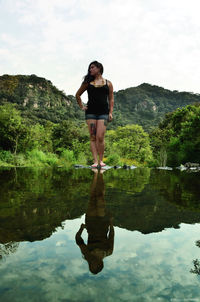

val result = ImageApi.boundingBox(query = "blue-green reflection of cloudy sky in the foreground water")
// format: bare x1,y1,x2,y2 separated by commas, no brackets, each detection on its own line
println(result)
0,216,200,302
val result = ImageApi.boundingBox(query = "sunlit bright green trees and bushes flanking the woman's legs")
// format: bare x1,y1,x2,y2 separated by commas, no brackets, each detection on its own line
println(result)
0,103,152,167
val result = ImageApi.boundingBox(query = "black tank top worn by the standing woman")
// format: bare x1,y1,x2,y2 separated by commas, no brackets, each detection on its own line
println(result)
86,80,109,115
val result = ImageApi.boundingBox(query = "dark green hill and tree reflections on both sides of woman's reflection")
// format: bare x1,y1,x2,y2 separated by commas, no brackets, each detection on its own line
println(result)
0,169,200,243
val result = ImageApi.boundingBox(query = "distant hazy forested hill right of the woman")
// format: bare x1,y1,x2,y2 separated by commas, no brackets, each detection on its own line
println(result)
115,83,200,130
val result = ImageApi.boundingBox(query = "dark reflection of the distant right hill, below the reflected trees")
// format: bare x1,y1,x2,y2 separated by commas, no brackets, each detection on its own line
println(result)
111,186,200,234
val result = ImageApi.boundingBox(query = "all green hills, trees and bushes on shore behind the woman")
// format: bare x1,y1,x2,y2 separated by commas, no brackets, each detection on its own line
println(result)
0,75,200,167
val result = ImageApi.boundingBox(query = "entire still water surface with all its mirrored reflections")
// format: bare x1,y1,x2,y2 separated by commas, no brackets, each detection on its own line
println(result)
0,168,200,302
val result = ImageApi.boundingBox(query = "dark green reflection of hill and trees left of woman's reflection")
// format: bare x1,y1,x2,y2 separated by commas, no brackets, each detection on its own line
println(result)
0,169,92,243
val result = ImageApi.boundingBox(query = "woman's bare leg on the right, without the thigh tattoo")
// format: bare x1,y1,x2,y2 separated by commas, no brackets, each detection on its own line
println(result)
96,120,106,165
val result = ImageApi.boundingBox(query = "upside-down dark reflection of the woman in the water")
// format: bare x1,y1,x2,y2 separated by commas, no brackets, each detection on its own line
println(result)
76,169,114,274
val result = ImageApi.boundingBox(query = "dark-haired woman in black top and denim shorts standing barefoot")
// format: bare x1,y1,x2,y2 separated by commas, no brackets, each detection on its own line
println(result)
76,61,114,168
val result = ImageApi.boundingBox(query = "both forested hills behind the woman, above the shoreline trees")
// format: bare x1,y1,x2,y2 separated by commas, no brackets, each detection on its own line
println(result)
0,75,200,130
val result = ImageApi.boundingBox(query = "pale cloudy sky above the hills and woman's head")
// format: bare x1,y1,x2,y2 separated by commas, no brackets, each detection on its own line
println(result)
0,0,200,99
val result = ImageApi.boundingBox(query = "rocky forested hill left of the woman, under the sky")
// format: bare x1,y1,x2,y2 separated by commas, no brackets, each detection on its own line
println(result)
0,75,84,124
